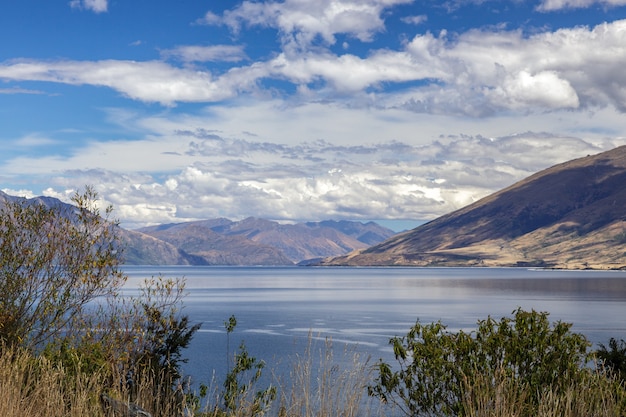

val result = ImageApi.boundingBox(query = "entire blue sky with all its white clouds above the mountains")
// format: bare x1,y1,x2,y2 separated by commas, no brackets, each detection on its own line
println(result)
0,0,626,228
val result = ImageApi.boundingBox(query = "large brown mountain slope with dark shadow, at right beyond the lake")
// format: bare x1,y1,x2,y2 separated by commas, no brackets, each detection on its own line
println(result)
323,146,626,269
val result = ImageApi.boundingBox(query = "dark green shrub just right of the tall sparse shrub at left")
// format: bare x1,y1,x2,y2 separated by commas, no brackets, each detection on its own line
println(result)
113,276,201,415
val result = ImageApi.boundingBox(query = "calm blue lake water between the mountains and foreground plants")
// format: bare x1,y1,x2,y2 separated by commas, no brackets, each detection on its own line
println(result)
124,266,626,382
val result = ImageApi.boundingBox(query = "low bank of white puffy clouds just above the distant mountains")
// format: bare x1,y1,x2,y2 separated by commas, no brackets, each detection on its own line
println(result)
94,133,600,228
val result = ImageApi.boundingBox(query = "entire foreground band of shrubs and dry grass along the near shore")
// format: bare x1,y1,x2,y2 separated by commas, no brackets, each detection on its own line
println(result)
0,188,626,417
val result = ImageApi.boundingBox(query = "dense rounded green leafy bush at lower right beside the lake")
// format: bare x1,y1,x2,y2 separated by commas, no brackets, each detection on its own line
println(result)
368,309,590,416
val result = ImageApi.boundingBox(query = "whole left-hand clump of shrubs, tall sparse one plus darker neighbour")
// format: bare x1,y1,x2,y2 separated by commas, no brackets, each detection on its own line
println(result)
0,187,199,415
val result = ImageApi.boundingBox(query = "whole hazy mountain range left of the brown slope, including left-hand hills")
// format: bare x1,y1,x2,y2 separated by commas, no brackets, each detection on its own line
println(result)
0,191,395,265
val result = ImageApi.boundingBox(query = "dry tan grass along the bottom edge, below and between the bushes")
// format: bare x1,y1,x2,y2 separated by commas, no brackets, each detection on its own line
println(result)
0,337,626,417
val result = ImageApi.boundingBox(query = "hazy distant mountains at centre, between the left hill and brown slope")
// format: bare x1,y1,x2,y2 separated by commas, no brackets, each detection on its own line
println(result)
137,217,394,265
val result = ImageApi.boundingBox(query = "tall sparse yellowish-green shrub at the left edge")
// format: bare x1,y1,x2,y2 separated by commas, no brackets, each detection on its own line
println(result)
0,187,125,348
